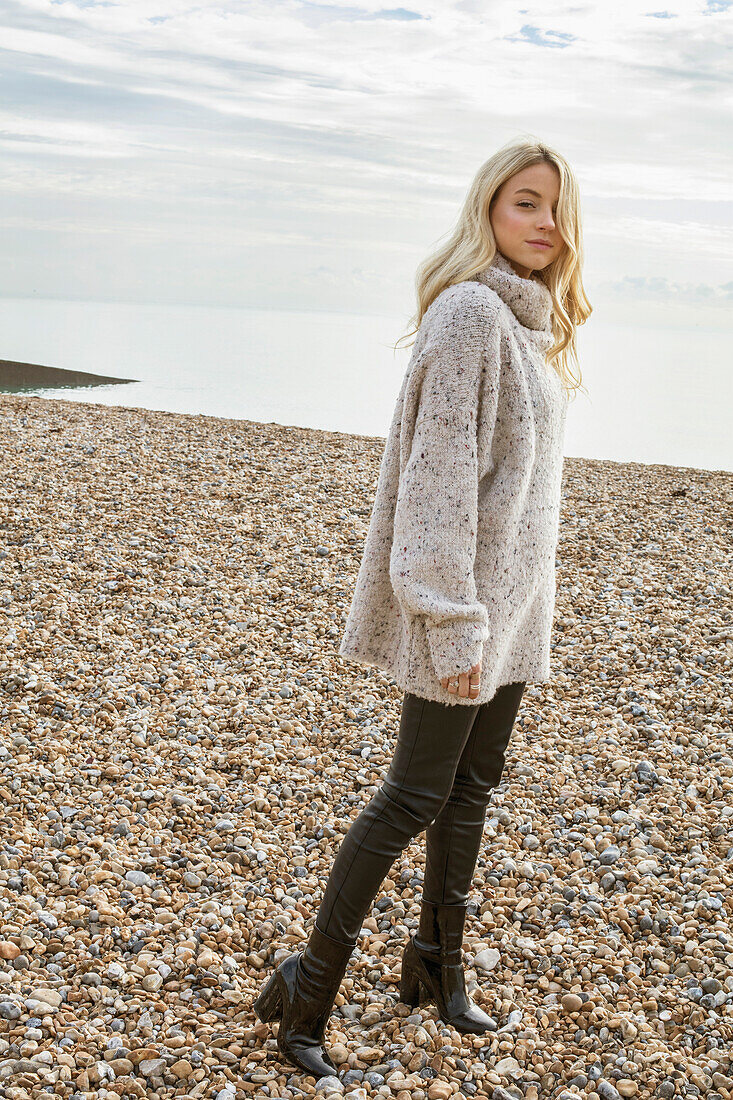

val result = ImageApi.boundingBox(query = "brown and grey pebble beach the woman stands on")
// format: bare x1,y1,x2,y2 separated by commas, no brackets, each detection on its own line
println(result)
0,394,733,1100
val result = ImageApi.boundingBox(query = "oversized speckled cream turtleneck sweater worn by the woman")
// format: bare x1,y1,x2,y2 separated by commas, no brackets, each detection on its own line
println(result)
339,252,568,706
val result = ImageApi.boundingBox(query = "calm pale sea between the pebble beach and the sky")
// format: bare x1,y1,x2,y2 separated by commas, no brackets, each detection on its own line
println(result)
0,298,733,470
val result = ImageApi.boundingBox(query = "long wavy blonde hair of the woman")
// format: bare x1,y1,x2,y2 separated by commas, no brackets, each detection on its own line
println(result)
393,139,593,396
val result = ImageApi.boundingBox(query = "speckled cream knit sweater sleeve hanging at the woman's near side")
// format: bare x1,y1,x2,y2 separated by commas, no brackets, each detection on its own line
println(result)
390,287,499,679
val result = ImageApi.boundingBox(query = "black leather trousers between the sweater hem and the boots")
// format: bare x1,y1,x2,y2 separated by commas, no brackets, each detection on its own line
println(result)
316,682,525,941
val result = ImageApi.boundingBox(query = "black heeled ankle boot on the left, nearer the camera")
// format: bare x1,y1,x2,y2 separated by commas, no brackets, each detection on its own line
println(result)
254,925,357,1078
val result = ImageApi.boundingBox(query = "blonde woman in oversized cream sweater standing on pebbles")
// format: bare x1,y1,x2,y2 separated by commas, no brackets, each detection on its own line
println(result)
254,135,591,1078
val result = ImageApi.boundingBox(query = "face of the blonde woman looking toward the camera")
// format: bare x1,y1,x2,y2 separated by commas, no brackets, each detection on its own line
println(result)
489,162,565,278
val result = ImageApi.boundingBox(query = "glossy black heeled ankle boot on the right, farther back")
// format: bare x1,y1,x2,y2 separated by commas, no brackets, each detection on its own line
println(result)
400,902,497,1035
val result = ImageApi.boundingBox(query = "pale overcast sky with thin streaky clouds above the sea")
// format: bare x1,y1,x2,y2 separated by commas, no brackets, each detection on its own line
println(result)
0,0,733,325
